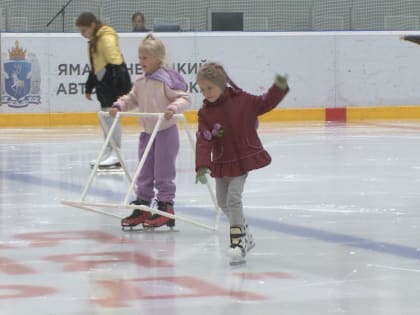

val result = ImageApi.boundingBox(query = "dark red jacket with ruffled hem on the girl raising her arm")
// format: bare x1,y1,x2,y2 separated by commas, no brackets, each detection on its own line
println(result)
195,85,289,177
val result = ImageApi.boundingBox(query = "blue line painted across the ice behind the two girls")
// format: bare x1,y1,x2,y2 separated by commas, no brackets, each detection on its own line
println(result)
0,170,420,260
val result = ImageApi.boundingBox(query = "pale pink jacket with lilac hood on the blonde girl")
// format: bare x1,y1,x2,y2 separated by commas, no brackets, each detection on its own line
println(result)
113,68,191,133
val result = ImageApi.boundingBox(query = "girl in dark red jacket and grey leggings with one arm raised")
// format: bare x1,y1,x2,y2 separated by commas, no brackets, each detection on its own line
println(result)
196,63,289,264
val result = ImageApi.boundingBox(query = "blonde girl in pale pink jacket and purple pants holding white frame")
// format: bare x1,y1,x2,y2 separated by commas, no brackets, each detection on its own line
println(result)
110,34,190,229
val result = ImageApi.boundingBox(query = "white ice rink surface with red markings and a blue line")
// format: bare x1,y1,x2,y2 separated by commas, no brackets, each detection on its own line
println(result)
0,122,420,315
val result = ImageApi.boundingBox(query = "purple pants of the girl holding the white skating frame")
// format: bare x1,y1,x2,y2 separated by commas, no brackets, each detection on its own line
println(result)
137,125,179,202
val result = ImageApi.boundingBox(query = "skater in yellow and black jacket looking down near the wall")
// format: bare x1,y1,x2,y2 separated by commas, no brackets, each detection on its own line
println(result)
76,12,131,168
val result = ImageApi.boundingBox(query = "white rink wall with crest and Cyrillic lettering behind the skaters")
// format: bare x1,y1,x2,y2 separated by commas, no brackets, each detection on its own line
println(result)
0,32,420,113
